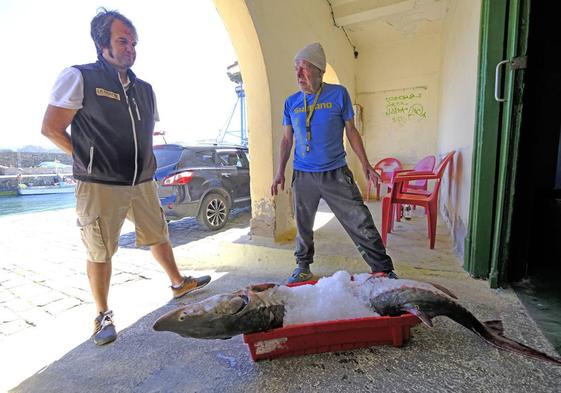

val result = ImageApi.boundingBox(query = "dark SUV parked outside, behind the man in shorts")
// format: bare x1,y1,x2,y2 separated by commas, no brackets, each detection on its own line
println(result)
154,144,251,230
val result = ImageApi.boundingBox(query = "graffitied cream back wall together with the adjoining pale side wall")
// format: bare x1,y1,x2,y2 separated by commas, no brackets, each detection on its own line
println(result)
355,0,481,255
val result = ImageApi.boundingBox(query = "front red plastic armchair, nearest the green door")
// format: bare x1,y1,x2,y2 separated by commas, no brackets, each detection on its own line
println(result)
382,151,455,249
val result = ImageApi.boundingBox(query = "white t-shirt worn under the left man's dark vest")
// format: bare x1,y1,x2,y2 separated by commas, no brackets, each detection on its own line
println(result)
49,67,160,121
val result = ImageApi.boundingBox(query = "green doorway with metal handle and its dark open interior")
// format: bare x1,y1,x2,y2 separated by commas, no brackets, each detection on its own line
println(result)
465,0,561,351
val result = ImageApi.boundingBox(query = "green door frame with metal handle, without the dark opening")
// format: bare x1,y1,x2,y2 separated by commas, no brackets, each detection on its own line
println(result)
464,0,531,288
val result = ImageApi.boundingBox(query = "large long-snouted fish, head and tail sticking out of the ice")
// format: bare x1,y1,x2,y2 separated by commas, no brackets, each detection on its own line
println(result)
154,274,561,365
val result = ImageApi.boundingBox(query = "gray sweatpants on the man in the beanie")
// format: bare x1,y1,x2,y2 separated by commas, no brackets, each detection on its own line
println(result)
292,166,393,272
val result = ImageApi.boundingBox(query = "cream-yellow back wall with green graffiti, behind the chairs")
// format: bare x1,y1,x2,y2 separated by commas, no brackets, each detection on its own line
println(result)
356,21,441,167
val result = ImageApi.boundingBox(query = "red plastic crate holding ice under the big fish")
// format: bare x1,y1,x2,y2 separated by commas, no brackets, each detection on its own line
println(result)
244,280,420,361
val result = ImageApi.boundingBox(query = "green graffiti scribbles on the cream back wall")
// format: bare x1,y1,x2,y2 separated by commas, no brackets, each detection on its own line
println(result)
384,88,427,125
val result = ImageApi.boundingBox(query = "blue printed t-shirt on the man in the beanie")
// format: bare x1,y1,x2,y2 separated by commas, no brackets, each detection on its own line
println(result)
282,83,354,172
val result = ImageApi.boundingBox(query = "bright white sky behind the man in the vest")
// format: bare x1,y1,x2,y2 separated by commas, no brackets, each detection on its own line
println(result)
0,0,239,149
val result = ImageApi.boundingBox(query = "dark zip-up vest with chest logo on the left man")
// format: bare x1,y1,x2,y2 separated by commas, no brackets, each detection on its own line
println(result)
71,56,156,185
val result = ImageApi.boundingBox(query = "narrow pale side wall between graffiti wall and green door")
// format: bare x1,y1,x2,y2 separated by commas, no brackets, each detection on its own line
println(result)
437,0,481,255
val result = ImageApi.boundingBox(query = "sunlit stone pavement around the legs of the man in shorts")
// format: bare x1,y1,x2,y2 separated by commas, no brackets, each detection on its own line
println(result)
0,209,250,392
